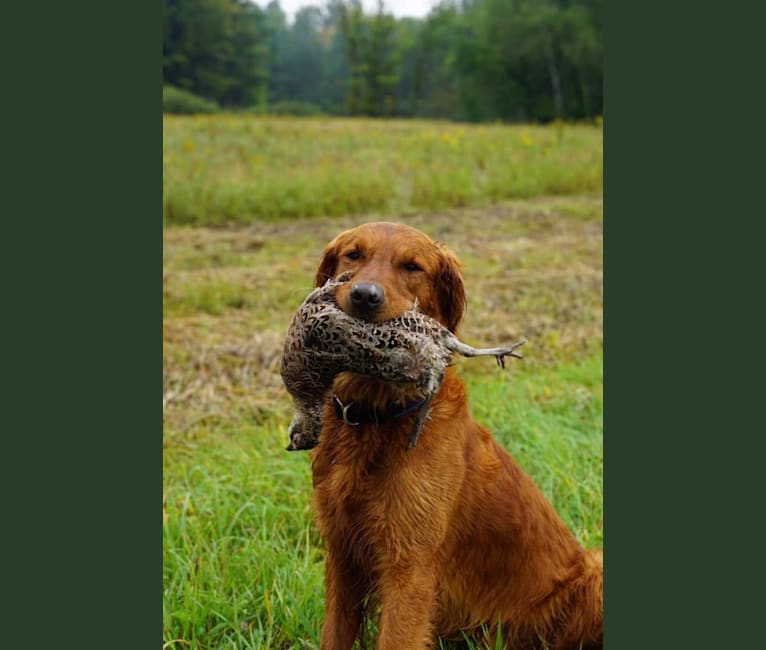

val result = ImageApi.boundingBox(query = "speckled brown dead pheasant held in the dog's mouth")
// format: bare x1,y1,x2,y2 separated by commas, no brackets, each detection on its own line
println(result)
280,273,526,451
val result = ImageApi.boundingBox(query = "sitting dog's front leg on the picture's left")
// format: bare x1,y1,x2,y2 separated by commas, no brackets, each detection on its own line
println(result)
320,550,365,650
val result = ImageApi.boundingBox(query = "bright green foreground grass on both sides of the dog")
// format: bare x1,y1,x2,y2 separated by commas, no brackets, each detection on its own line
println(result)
164,355,603,648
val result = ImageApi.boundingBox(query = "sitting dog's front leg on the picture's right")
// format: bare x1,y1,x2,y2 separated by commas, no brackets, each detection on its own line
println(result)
378,567,435,650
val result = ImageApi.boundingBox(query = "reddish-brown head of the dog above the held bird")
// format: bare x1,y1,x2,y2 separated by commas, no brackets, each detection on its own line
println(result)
316,222,466,332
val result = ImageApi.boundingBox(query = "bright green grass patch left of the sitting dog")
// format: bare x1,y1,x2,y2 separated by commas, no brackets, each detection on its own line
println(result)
163,422,322,648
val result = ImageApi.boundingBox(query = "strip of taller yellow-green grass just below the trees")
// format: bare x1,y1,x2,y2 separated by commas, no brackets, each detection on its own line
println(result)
163,115,603,225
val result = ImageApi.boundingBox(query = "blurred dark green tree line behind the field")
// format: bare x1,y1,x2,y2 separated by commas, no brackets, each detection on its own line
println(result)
163,0,603,121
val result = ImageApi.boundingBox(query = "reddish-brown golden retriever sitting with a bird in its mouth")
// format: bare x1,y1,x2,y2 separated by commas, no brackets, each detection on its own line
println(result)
311,222,603,650
